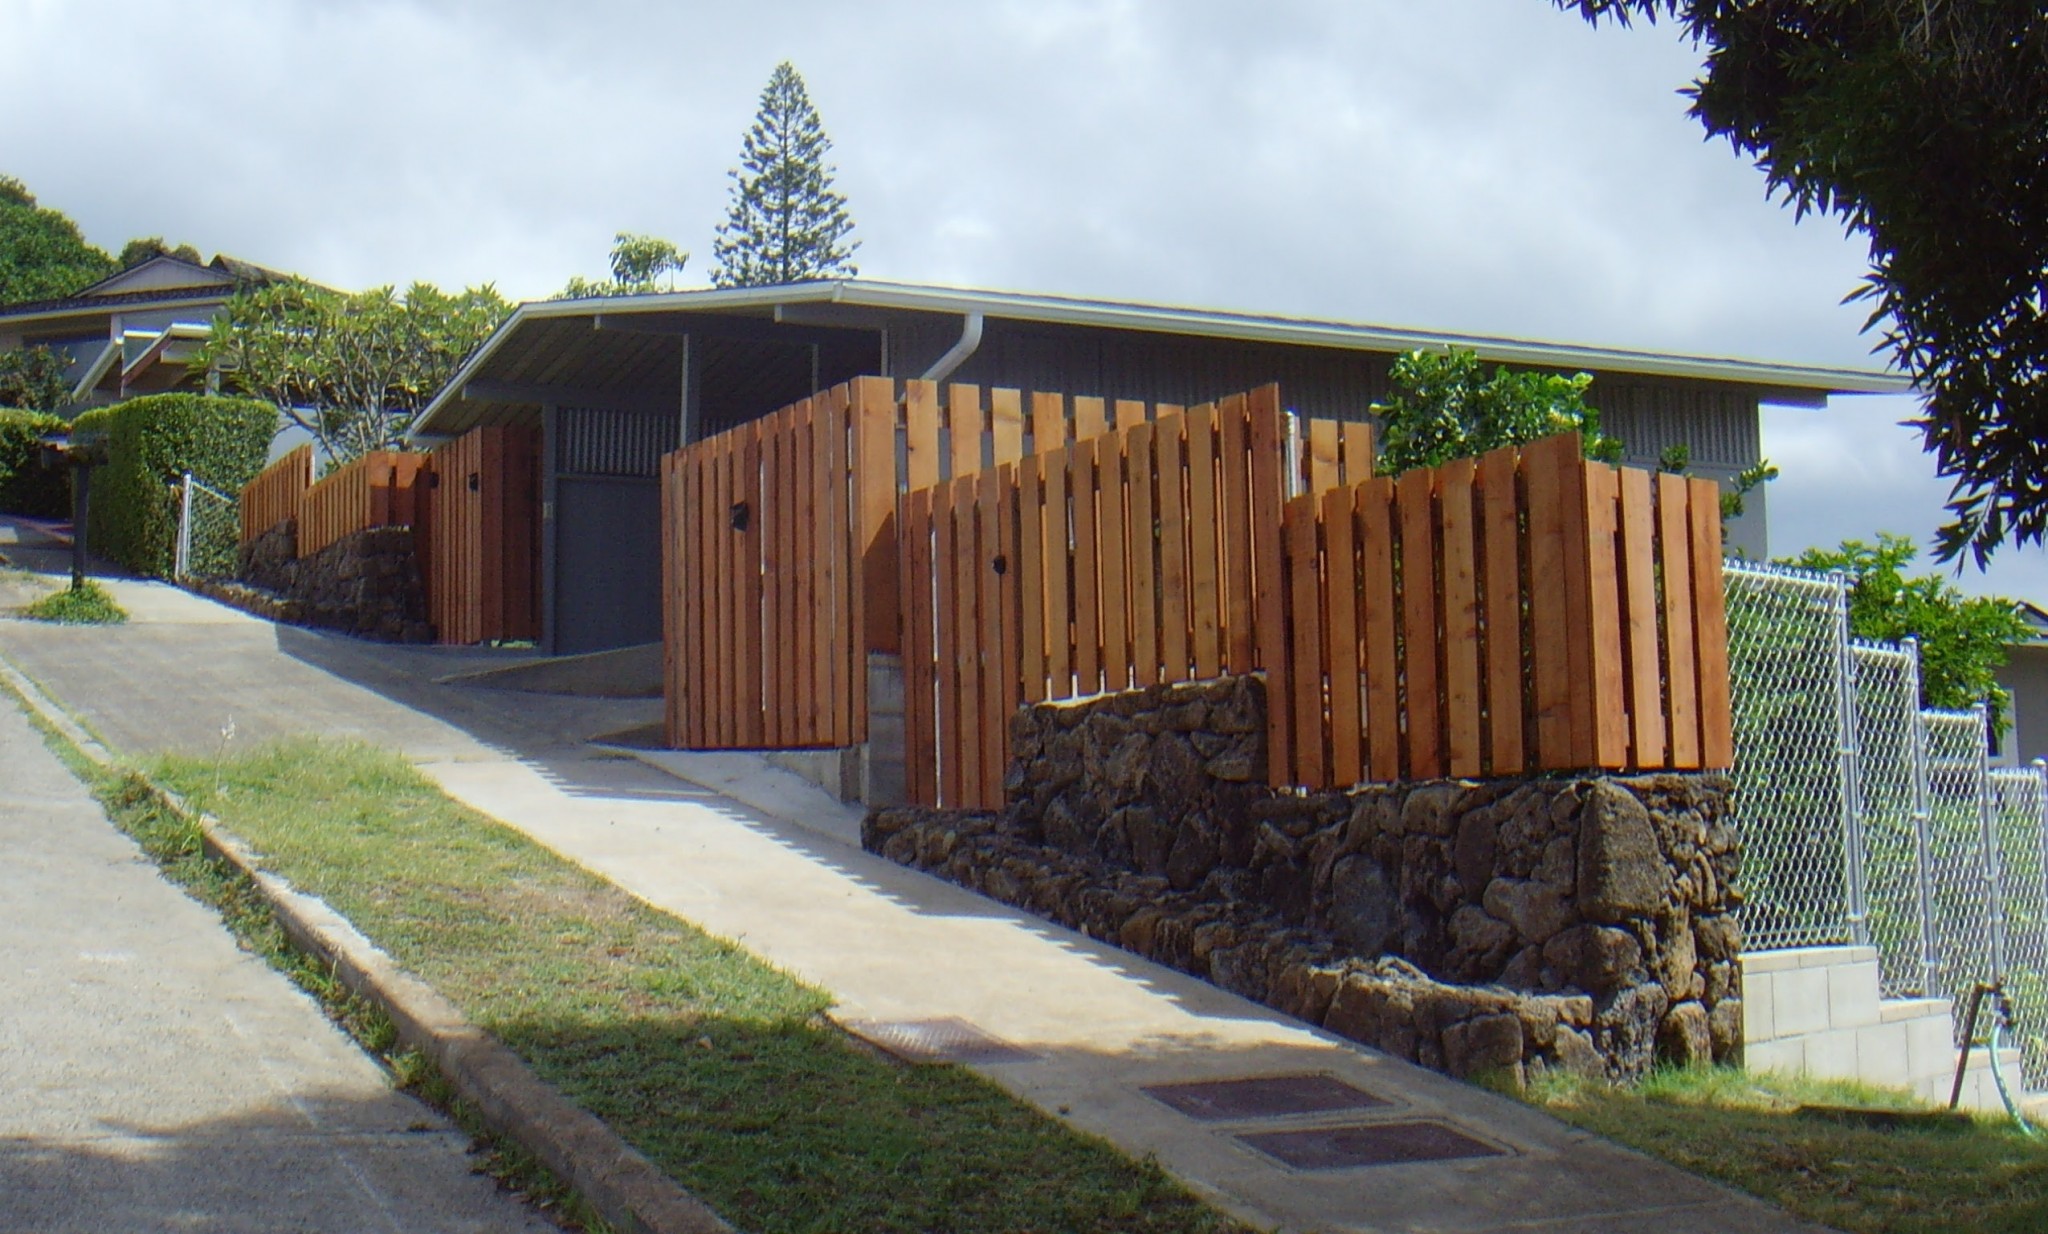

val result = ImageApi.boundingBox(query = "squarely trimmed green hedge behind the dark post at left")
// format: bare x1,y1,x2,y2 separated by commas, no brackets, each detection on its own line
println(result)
72,395,276,577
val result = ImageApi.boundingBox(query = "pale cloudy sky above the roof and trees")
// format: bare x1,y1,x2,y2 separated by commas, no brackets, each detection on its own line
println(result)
0,0,2048,600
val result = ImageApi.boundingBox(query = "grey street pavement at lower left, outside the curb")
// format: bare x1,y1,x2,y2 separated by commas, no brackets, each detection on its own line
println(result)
0,687,555,1234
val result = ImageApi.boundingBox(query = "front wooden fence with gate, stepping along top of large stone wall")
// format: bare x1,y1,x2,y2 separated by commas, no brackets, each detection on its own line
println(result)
899,387,1731,808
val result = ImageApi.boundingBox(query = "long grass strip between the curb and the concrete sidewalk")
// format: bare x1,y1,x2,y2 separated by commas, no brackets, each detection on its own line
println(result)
150,741,1239,1234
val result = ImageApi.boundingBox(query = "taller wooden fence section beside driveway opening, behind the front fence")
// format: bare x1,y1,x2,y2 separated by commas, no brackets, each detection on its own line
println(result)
662,377,1360,749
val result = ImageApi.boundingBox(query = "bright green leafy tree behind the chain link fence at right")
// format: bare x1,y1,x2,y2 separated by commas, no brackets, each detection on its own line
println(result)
1792,532,2030,731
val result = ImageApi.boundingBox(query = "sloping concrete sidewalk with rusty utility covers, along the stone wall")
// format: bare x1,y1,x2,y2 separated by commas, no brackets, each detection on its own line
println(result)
0,540,1810,1234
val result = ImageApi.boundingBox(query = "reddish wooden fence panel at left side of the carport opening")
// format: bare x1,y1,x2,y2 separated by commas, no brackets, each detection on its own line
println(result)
414,426,541,645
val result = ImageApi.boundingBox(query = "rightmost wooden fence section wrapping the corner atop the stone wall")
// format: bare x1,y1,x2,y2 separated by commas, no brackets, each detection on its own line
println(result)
1268,434,1733,788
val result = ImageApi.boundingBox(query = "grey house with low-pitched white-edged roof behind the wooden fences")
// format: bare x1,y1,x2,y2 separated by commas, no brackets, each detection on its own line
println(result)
412,280,1905,653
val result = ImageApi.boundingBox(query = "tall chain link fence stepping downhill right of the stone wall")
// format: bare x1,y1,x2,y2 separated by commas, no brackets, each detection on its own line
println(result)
1726,561,2048,1089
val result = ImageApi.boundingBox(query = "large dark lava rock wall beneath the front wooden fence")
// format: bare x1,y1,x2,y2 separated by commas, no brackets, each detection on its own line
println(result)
864,677,1741,1078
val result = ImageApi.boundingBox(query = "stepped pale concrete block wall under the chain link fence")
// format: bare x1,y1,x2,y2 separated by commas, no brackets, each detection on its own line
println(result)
1743,947,2019,1109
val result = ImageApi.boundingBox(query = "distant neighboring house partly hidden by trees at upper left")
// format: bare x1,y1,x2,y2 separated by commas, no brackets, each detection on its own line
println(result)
0,254,289,413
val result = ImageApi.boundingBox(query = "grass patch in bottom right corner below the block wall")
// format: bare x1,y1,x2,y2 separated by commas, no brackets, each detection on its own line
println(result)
1522,1066,2048,1234
